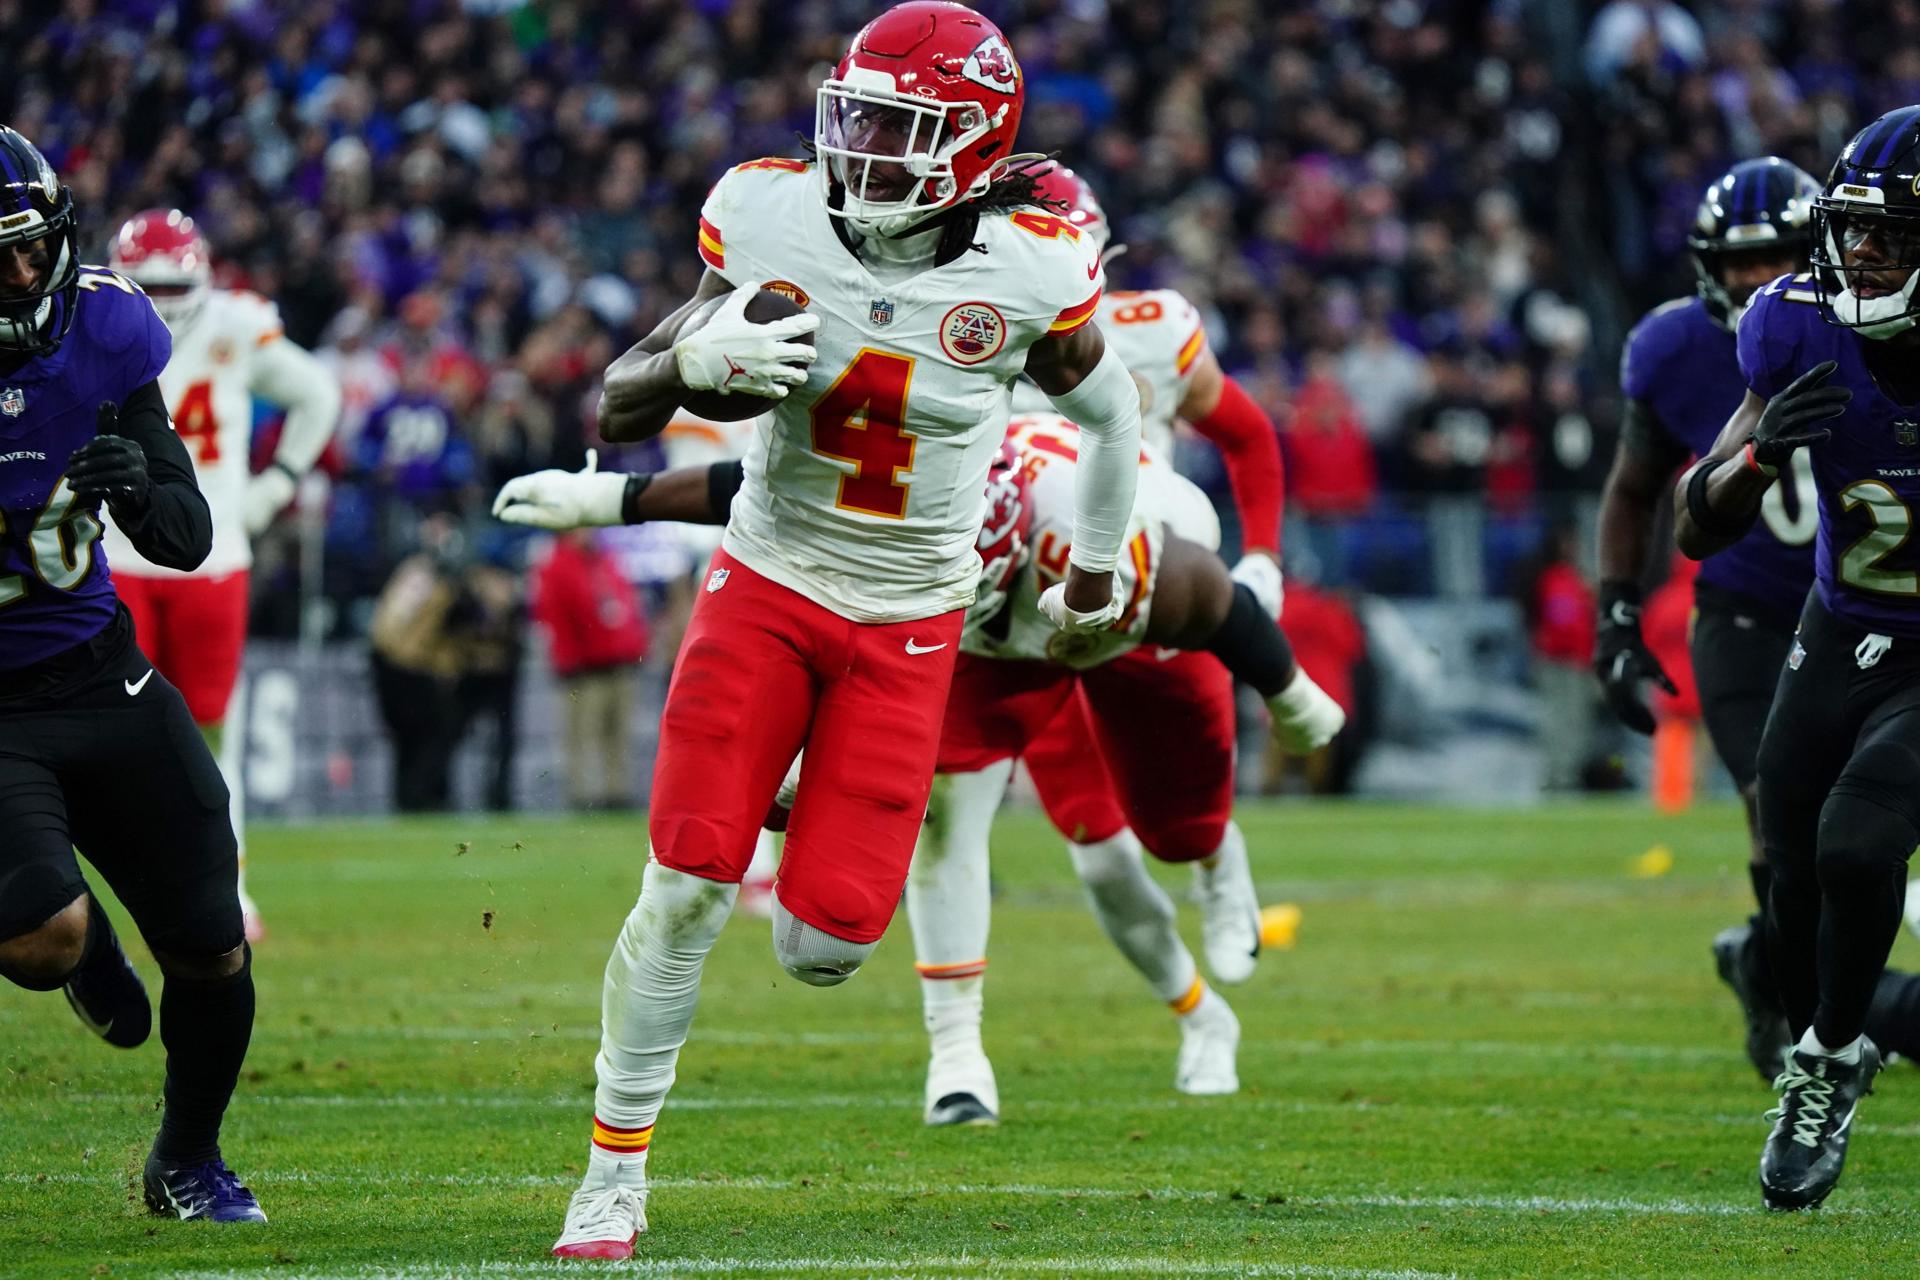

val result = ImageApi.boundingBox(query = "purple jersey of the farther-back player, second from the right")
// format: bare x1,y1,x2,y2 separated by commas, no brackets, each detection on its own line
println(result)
1620,297,1818,620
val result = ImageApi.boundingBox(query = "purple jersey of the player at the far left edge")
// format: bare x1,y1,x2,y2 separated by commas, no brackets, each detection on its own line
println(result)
0,267,173,670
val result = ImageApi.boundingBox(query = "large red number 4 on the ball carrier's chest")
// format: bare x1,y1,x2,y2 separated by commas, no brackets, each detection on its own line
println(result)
812,347,920,520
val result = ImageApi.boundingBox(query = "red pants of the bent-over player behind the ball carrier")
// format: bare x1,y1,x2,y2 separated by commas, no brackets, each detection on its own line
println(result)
939,649,1235,862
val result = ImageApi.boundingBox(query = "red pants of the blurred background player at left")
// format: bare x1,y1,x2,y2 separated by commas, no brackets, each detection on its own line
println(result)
113,568,248,725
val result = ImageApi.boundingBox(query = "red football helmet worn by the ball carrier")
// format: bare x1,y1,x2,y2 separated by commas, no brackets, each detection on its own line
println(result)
814,0,1027,236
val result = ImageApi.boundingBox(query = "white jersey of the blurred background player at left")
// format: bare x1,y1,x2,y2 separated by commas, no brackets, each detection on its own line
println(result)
106,290,282,578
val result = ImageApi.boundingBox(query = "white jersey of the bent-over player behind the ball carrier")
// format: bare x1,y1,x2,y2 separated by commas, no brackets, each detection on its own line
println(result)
960,415,1219,672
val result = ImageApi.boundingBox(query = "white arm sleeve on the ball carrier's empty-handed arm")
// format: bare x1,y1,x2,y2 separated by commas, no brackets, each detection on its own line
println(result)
1052,347,1140,574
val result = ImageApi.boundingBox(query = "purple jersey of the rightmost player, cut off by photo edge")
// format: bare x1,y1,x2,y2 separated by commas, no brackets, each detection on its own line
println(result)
1740,274,1920,639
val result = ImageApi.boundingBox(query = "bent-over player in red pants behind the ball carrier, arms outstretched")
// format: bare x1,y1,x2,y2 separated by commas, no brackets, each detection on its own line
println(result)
493,415,1344,1125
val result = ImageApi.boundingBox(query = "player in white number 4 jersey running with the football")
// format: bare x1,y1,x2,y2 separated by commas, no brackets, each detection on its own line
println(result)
533,0,1140,1257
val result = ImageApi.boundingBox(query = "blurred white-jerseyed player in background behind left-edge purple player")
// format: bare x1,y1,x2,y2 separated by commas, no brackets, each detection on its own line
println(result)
106,209,340,942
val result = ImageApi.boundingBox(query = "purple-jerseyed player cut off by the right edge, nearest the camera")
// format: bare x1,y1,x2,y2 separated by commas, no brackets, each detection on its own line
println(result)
1674,106,1920,1209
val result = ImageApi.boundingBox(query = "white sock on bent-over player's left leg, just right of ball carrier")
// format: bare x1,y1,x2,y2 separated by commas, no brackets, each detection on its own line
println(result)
906,760,1014,1055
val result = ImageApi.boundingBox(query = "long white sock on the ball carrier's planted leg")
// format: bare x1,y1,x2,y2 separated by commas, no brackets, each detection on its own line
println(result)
588,858,739,1186
